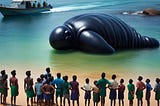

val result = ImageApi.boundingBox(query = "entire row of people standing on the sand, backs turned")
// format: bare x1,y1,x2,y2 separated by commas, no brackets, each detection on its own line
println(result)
0,67,160,106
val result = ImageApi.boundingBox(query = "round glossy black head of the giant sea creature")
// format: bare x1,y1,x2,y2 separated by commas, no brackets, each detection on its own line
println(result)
49,26,72,50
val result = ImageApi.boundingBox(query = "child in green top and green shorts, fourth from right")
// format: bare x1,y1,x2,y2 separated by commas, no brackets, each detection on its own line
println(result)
127,79,135,106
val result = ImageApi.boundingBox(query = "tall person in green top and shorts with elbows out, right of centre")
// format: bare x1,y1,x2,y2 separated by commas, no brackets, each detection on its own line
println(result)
97,72,111,106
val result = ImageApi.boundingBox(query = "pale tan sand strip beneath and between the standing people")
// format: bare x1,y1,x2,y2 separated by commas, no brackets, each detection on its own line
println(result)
1,66,157,106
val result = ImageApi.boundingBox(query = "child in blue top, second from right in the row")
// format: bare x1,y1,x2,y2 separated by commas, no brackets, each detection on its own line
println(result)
146,79,152,106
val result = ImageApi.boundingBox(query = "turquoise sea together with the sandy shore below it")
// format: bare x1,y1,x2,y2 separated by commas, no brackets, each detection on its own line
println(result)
0,0,160,106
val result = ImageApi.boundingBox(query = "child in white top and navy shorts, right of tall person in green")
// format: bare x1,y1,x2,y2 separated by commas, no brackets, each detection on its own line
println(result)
109,74,118,106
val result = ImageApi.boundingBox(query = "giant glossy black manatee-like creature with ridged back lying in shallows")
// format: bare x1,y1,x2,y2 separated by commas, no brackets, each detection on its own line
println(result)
49,14,159,54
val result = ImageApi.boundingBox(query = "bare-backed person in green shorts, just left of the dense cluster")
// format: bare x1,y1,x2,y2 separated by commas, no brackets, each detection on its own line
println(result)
24,71,35,106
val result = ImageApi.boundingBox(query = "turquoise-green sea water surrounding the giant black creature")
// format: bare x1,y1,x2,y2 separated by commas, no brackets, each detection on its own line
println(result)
0,0,160,73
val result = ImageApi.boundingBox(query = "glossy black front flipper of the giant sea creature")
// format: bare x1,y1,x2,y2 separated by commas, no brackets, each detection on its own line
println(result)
79,30,115,54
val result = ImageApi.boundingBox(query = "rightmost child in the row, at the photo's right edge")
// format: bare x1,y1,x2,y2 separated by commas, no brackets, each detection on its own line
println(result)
154,78,160,106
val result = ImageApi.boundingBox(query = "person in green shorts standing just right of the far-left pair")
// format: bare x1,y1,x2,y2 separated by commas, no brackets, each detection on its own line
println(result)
9,70,19,105
